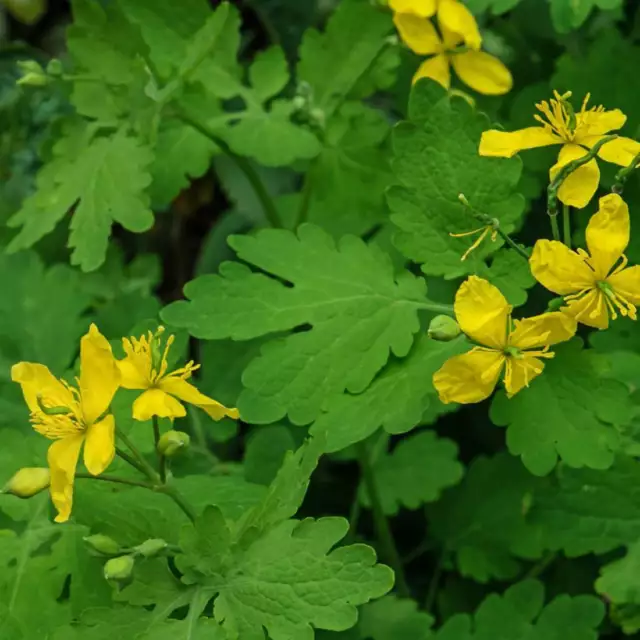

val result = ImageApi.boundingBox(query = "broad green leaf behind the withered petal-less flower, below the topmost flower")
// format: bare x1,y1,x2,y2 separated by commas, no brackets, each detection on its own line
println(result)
388,80,524,278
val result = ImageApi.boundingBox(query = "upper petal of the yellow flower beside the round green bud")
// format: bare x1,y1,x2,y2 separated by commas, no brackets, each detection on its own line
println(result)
453,276,511,349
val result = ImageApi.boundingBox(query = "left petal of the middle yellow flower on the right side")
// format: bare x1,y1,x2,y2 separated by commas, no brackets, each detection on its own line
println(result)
529,240,595,296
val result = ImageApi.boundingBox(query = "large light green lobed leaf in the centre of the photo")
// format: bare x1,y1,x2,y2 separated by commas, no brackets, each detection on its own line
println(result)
162,224,436,424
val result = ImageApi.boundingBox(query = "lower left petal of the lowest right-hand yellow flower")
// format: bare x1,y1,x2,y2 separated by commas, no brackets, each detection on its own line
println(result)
433,349,505,404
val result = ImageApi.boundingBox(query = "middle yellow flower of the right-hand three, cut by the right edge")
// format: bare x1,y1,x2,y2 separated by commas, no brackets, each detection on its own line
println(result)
530,194,640,329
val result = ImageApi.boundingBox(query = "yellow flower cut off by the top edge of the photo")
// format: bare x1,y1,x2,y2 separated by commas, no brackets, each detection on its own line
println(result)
391,0,513,95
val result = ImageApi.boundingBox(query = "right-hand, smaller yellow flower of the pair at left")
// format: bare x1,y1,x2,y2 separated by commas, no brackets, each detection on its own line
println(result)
118,327,239,420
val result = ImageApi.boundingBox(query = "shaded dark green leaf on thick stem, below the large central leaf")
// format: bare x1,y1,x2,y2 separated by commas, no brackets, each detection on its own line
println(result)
359,431,464,515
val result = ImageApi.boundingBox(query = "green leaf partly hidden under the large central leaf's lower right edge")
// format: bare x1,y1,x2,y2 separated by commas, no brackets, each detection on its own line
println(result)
311,333,468,452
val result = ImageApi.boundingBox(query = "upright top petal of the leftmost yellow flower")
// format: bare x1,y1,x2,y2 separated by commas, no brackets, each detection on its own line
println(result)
80,324,120,424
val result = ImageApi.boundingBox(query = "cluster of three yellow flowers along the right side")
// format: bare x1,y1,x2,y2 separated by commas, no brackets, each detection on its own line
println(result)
433,92,640,404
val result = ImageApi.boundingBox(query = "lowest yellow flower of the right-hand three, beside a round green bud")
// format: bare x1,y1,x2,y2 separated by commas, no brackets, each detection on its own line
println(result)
433,276,576,404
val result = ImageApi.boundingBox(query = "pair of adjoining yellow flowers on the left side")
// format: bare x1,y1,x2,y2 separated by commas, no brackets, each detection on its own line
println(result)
11,324,239,522
